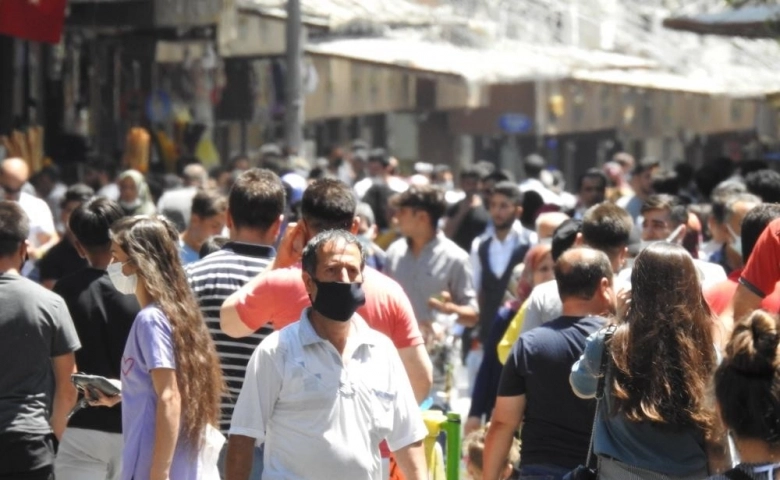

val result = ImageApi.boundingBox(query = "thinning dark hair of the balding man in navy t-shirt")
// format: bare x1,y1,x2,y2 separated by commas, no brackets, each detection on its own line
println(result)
555,247,612,301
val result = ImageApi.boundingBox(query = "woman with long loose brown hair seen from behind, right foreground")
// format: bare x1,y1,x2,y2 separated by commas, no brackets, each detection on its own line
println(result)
571,242,727,480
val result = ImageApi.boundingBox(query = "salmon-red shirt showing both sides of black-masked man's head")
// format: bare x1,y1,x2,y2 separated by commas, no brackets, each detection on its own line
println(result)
236,266,423,349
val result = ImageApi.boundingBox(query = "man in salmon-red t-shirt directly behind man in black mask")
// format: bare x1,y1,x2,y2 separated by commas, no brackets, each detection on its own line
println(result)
220,179,432,402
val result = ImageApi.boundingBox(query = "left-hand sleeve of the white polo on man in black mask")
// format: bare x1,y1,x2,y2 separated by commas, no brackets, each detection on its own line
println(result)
230,333,283,445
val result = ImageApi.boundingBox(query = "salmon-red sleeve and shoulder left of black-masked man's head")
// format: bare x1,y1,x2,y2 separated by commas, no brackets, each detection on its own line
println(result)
236,268,310,330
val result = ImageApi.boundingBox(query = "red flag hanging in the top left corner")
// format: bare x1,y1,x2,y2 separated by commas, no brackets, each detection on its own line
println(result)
0,0,67,43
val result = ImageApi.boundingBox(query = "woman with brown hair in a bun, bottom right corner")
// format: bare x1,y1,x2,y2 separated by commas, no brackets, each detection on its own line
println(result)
711,310,780,480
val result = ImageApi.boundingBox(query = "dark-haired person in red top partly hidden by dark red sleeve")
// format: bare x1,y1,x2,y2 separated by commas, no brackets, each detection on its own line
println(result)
704,204,780,315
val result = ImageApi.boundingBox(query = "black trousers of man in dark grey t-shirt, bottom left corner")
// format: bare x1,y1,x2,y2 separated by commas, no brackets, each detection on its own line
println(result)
0,432,59,480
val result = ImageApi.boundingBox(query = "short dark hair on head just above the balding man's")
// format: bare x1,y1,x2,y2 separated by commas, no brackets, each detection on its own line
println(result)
582,202,634,257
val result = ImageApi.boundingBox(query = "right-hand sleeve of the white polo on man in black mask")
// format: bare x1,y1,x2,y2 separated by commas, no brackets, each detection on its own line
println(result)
387,348,428,452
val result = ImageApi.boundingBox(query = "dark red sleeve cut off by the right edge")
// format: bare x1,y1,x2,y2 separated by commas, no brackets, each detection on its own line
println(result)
739,220,780,298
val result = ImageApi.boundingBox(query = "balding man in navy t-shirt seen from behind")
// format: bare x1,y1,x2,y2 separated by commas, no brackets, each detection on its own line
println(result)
484,248,615,479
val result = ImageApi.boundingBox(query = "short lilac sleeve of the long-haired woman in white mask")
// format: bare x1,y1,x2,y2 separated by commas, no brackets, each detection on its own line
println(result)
135,308,176,371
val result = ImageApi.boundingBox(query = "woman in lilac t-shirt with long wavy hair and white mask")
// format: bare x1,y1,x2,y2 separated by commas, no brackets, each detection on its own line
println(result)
99,216,222,480
